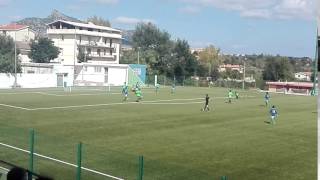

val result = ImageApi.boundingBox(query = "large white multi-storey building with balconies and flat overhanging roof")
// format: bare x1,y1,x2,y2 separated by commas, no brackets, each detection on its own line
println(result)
47,20,122,65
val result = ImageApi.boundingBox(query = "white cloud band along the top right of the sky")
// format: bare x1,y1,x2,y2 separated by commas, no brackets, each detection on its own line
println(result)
177,0,317,20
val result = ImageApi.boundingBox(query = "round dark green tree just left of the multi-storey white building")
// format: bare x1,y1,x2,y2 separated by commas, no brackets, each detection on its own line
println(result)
28,38,60,63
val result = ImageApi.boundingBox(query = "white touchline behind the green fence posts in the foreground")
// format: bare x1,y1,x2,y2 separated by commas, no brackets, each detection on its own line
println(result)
0,142,124,180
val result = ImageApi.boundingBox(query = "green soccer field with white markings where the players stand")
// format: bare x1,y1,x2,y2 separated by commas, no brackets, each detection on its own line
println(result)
0,87,317,180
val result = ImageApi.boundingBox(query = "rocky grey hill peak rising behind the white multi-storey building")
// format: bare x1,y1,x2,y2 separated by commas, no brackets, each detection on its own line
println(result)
16,10,83,36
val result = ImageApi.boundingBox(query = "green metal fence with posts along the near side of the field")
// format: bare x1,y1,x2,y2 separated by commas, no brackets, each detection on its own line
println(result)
0,125,227,180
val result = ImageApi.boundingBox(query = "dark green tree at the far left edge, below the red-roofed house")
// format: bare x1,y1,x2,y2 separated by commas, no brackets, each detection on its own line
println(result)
0,35,21,73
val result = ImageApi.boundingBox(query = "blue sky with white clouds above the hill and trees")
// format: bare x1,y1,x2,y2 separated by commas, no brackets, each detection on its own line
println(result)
0,0,319,58
